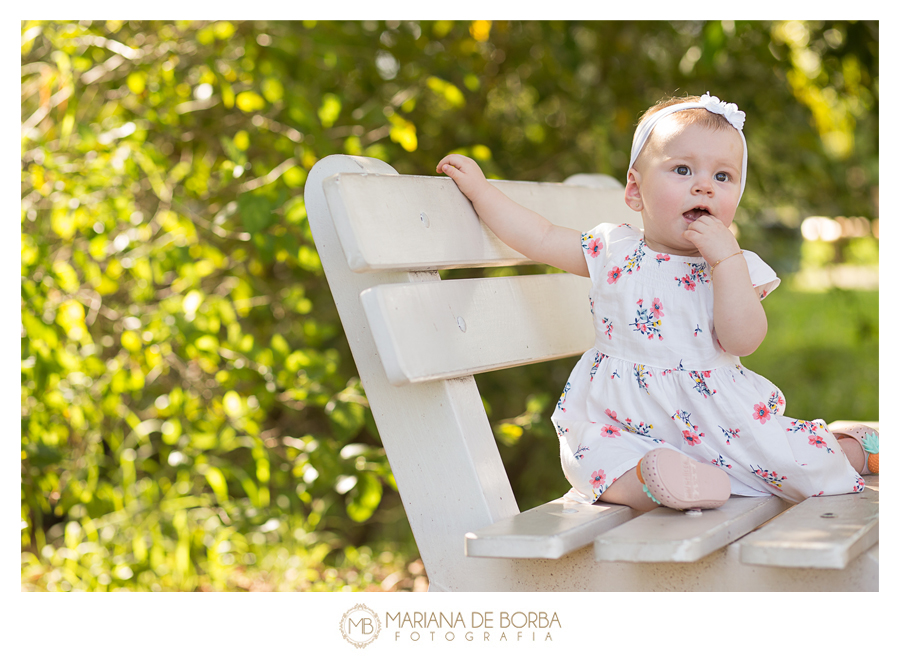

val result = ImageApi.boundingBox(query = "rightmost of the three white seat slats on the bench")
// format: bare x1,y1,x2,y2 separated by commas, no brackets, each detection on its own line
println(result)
738,475,878,569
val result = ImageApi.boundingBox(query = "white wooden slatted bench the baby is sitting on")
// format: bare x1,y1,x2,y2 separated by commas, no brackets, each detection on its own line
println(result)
304,155,878,591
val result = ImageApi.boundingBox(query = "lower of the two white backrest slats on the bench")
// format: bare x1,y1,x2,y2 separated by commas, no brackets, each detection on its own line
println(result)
360,274,594,385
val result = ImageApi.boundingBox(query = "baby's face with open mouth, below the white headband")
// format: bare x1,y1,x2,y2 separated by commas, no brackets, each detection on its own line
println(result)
634,115,744,256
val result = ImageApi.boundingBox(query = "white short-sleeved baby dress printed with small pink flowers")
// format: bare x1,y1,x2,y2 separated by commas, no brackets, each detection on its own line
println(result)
552,224,865,502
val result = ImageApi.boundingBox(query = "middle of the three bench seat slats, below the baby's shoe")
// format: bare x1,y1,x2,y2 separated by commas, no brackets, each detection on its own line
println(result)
594,496,789,562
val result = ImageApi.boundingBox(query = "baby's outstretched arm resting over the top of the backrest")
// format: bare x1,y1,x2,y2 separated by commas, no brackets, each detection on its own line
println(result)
437,154,589,276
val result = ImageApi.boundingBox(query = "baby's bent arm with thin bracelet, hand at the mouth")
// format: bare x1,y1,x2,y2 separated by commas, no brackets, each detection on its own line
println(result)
684,215,768,356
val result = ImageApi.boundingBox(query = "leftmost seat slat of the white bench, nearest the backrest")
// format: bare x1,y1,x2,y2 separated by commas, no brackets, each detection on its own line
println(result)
466,498,639,559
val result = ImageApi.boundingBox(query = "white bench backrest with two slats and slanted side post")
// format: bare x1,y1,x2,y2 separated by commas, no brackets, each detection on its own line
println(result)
304,156,640,590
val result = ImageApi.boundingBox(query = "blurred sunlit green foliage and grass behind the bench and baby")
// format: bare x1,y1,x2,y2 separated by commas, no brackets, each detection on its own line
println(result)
21,21,879,591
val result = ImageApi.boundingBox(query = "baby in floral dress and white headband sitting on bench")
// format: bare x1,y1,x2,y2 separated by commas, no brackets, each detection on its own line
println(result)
437,94,878,510
